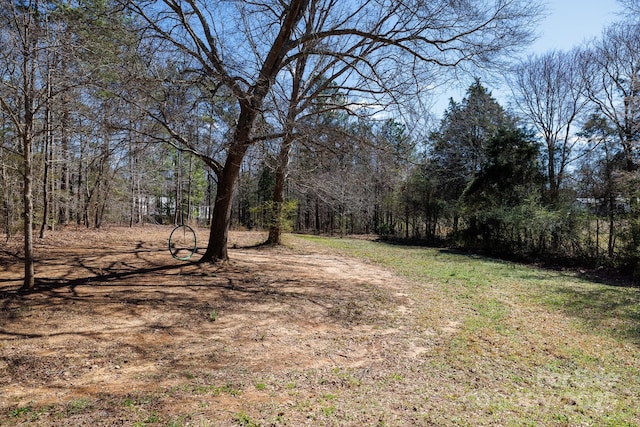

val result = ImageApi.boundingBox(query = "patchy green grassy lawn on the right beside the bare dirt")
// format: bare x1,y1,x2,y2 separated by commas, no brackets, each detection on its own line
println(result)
303,237,640,426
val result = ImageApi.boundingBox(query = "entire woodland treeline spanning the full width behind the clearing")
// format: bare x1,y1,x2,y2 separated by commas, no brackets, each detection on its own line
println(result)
0,0,640,280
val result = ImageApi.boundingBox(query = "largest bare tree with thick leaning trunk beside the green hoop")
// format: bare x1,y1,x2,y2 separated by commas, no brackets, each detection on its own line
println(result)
127,0,540,261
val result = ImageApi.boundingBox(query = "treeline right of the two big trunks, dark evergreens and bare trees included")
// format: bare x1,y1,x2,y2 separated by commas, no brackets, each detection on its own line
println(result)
238,44,640,274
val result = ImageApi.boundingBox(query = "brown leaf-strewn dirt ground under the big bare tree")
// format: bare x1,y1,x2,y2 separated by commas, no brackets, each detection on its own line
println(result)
0,226,422,426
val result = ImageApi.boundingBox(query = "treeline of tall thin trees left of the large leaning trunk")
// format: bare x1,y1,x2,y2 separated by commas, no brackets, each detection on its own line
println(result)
0,1,215,238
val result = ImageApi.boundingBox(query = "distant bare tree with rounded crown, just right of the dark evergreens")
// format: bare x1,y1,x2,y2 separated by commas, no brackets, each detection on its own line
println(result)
510,50,588,203
